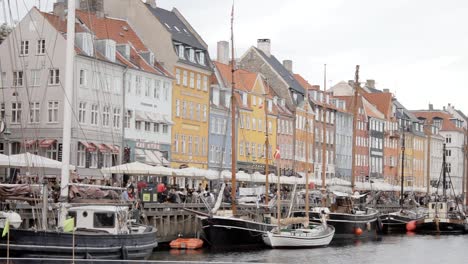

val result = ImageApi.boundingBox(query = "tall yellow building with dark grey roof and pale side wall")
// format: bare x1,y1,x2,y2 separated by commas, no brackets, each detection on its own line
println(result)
103,0,212,168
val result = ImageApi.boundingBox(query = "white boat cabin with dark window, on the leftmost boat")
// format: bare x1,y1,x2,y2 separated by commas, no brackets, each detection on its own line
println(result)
68,205,128,234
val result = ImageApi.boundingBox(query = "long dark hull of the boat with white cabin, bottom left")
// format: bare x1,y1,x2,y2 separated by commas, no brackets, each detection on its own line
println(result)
0,227,158,260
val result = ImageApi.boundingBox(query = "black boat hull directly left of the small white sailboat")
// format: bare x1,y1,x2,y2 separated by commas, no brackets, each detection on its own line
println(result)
201,216,275,248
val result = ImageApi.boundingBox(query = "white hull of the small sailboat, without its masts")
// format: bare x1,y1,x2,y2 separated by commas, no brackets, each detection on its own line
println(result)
263,226,335,248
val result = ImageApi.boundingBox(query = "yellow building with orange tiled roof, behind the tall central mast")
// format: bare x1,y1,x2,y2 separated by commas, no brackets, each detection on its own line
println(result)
215,62,277,173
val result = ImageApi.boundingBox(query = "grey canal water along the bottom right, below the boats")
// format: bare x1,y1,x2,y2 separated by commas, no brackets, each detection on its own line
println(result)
151,234,468,264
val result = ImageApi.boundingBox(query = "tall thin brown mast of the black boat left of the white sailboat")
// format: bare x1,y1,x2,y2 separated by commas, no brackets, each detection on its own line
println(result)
231,1,237,215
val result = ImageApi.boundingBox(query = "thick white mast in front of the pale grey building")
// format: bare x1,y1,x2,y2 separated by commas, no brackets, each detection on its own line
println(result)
59,1,76,226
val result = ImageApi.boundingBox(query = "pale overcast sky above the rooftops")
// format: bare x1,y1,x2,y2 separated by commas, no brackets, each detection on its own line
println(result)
0,0,468,113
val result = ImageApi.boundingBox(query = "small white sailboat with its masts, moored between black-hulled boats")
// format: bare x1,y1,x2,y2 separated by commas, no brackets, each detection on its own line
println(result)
262,92,335,248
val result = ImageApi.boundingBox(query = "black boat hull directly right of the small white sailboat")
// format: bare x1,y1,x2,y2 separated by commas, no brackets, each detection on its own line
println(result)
294,212,380,241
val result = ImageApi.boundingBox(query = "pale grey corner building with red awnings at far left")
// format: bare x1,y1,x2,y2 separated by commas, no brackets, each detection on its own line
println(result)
0,5,125,178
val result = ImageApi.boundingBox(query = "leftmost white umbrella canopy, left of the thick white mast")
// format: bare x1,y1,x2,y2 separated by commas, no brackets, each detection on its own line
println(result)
9,152,75,170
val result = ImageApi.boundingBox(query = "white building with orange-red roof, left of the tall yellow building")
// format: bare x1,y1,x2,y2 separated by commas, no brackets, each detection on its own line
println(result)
76,10,174,166
